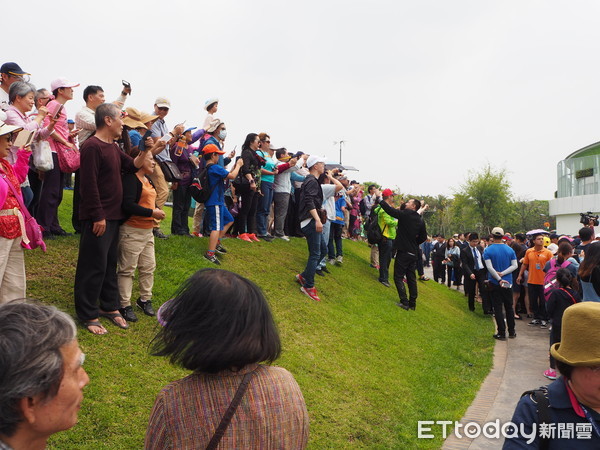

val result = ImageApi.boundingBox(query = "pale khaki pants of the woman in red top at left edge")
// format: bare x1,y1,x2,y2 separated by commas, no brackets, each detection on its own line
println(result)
0,236,25,304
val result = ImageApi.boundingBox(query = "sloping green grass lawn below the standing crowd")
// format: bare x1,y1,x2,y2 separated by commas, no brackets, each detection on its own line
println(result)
26,191,494,449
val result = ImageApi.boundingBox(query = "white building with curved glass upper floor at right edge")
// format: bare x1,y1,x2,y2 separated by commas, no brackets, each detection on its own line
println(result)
550,142,600,235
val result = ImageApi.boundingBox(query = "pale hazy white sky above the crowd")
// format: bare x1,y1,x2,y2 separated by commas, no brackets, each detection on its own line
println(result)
8,0,600,199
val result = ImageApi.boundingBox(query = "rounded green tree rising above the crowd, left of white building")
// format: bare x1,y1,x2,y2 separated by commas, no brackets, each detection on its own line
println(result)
455,164,512,233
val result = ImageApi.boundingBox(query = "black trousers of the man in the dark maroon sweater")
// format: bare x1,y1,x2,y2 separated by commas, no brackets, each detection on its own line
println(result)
74,220,121,321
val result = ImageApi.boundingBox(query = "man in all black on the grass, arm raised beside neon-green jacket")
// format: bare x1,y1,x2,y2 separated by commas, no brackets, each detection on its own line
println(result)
377,192,427,310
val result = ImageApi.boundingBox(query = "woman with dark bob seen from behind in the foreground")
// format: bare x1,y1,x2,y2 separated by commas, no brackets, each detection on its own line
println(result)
145,269,309,449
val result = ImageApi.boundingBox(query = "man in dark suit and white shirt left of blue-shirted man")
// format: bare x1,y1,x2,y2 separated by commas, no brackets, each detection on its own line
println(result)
460,233,492,314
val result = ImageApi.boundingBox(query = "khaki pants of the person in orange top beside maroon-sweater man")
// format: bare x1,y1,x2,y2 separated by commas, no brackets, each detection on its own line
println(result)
117,225,156,308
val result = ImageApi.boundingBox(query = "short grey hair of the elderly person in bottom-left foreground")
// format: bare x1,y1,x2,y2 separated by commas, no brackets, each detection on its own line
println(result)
0,299,77,436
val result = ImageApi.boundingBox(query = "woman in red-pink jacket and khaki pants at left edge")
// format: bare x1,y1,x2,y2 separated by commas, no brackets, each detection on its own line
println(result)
0,122,31,303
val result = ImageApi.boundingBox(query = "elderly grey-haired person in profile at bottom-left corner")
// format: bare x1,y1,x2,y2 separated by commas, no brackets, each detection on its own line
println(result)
0,300,89,450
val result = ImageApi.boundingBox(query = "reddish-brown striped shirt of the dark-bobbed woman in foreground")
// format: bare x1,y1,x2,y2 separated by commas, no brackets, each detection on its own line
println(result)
145,364,309,449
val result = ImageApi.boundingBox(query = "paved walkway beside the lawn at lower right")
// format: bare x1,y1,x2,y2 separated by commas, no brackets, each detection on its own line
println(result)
425,268,550,450
